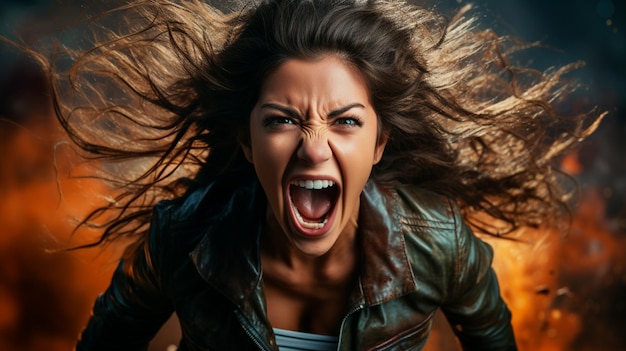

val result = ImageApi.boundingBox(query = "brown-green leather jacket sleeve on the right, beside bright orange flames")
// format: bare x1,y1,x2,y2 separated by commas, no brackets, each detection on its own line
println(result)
442,201,517,351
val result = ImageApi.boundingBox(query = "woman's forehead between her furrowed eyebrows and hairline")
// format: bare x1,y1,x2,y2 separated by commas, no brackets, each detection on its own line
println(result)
259,55,369,107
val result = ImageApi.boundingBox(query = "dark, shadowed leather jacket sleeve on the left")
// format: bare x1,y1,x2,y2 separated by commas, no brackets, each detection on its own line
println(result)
76,205,173,351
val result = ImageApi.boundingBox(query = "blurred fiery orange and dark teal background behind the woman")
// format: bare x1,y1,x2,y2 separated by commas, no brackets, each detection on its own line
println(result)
0,0,626,351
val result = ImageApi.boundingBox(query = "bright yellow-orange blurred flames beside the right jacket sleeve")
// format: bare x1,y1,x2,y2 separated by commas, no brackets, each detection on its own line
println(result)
483,229,581,351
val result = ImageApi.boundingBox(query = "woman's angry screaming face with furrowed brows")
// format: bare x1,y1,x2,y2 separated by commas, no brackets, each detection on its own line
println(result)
243,56,386,256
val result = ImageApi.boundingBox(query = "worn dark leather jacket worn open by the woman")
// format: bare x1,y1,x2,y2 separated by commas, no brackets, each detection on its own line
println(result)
77,181,516,351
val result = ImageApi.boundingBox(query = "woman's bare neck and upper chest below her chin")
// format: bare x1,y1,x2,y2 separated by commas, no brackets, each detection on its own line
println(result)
261,201,359,335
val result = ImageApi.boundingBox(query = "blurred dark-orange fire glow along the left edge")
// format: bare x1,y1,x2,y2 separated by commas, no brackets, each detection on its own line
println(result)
0,61,123,351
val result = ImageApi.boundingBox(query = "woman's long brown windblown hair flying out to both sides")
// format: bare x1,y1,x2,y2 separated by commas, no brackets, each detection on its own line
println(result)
28,0,602,248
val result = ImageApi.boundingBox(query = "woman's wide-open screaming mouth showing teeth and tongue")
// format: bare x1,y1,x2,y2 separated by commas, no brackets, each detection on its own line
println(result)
289,180,339,232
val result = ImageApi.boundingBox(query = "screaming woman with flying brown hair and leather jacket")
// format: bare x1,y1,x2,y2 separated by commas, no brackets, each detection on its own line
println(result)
30,0,594,350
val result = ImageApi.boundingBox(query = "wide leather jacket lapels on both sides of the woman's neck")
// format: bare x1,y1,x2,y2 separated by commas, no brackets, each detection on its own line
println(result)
190,180,417,306
